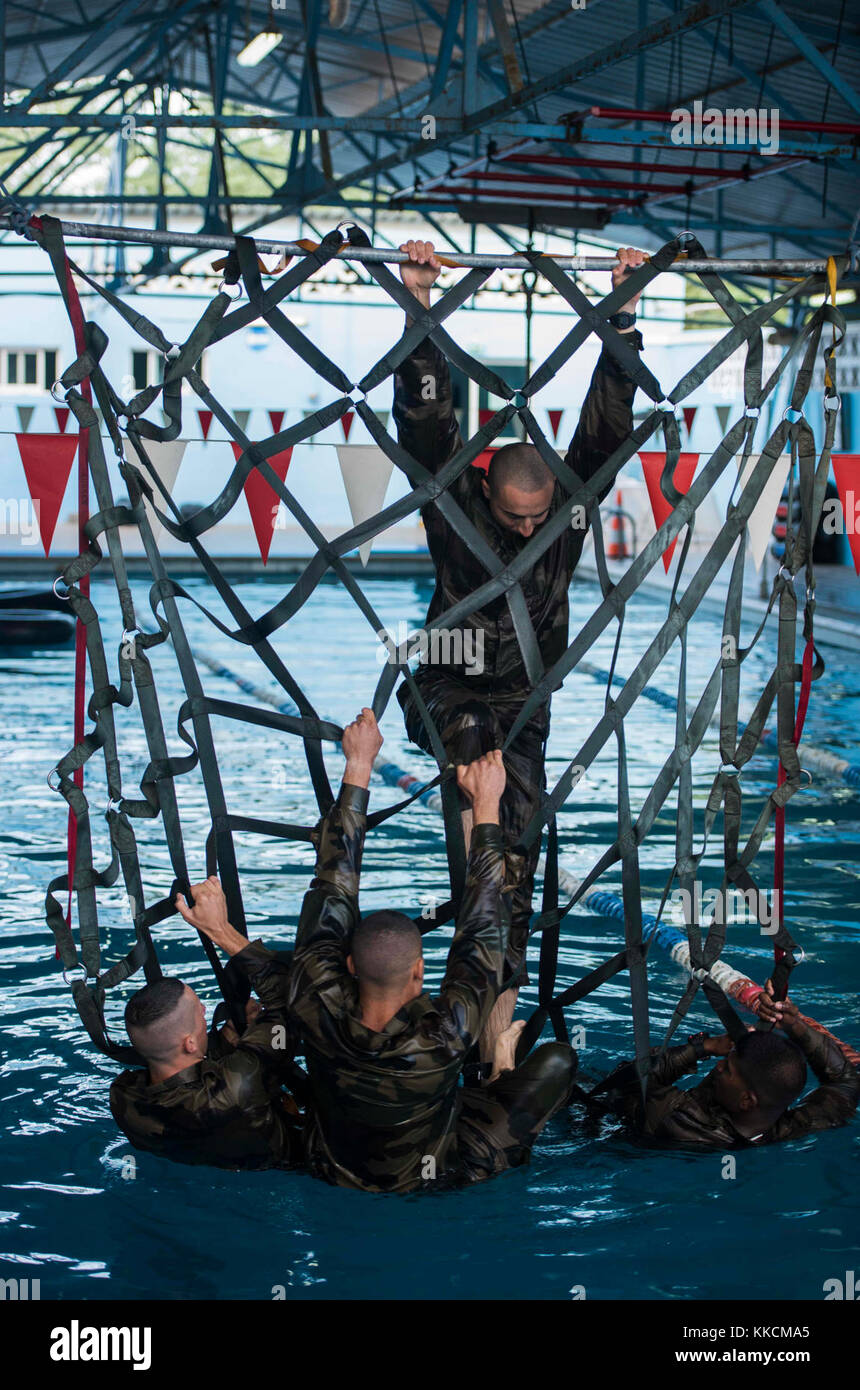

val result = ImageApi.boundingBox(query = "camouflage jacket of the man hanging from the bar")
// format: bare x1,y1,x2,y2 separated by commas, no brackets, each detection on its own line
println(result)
393,329,642,696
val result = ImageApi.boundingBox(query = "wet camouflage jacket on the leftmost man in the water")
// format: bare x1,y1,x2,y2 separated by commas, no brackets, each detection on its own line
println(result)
110,941,301,1169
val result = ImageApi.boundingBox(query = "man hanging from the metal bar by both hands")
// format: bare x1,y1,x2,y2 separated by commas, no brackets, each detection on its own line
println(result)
393,240,645,1066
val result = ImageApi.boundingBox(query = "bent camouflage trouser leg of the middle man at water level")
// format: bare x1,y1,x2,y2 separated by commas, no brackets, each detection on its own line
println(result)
457,1043,577,1183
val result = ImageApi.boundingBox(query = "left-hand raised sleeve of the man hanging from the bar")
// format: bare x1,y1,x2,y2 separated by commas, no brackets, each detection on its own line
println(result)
393,338,463,474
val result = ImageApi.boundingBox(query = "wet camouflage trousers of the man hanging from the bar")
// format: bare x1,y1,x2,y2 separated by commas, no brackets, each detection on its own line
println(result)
397,666,549,984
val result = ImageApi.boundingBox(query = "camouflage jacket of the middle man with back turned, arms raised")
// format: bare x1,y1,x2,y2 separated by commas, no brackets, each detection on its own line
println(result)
290,785,507,1193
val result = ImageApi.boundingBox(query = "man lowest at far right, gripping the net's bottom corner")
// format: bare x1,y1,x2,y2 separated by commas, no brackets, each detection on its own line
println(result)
600,980,860,1150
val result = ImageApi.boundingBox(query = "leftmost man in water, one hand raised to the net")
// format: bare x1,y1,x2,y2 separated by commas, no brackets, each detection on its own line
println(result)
110,917,301,1169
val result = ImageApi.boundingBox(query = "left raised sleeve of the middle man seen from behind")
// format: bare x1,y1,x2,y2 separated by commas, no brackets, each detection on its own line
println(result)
289,784,368,1002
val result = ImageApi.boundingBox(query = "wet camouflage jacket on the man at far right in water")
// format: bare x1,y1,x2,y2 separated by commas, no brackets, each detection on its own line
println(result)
608,1029,860,1150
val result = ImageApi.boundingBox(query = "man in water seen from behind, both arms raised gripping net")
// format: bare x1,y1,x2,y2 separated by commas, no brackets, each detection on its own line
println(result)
289,709,577,1193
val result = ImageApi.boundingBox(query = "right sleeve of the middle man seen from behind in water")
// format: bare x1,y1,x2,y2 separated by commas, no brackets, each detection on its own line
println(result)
438,824,510,1052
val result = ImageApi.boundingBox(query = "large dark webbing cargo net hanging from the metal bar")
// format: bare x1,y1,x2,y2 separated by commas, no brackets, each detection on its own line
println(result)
31,217,845,1081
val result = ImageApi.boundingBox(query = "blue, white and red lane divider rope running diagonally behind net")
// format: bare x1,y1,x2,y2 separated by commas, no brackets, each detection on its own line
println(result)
195,652,860,1066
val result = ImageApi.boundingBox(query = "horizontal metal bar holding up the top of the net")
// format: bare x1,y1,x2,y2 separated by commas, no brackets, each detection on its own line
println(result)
0,217,827,277
